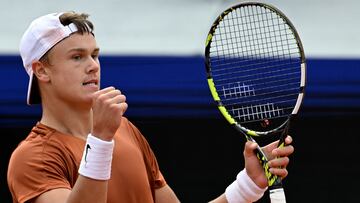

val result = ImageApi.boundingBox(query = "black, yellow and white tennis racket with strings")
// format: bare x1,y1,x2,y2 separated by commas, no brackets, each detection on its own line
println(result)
205,2,306,203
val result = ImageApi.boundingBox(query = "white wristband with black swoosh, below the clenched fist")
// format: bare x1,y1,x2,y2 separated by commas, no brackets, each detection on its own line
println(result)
79,134,114,180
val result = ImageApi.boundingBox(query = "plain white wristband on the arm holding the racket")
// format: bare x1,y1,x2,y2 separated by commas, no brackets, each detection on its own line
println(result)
225,169,267,203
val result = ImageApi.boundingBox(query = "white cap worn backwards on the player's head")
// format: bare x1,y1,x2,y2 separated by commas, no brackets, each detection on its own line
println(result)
20,13,78,105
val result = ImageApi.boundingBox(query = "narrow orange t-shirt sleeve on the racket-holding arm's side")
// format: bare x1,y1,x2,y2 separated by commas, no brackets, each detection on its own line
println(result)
129,121,166,189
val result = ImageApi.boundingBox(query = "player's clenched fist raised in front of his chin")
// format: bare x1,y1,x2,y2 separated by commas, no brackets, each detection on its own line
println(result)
92,87,128,141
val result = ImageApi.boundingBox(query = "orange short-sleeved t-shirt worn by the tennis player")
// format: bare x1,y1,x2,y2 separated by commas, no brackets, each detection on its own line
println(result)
7,117,166,203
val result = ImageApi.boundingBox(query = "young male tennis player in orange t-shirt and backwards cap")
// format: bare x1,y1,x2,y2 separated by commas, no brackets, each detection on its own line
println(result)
7,12,294,203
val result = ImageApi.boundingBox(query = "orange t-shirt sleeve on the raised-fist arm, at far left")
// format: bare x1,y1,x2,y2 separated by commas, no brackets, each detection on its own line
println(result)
7,137,71,202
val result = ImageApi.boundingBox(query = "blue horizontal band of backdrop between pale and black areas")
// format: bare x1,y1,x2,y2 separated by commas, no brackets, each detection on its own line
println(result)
0,55,360,125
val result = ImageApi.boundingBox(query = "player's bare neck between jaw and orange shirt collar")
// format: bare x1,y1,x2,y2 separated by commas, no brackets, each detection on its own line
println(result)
40,98,92,138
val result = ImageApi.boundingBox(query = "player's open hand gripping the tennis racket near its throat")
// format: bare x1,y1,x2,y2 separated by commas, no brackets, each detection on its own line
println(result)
244,135,294,188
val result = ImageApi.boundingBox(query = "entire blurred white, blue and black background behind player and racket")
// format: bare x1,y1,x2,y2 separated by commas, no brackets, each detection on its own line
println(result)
0,0,360,203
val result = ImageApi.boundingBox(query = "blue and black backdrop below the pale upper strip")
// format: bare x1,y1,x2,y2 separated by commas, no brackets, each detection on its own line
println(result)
0,55,360,203
